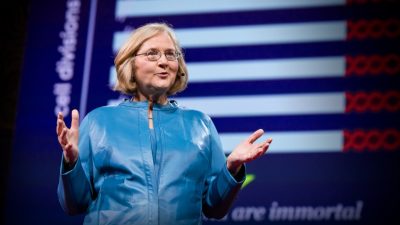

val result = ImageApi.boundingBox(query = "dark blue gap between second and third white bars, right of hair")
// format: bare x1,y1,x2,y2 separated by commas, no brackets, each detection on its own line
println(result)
184,40,400,62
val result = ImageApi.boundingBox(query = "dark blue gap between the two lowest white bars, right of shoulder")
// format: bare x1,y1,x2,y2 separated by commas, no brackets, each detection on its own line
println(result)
212,112,400,133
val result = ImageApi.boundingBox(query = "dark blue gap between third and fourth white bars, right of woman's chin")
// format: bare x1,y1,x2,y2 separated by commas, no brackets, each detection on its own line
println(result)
178,75,400,97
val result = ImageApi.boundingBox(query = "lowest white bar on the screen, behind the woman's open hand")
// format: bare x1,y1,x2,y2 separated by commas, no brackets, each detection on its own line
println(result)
220,130,344,154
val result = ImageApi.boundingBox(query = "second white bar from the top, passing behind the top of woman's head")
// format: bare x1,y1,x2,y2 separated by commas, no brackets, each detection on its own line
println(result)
113,21,346,50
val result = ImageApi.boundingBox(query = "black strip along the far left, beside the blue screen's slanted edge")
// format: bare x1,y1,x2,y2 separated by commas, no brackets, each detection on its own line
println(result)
0,0,30,224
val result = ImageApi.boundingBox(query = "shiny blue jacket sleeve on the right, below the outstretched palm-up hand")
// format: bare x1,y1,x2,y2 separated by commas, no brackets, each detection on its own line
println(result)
203,119,246,219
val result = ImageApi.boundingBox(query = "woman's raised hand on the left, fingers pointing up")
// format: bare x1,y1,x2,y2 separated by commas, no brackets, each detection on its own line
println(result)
56,109,79,168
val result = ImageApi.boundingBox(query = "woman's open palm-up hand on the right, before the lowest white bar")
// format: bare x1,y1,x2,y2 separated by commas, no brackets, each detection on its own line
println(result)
226,129,272,175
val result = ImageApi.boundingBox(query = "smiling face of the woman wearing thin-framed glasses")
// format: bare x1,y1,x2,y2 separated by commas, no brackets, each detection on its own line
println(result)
134,32,178,97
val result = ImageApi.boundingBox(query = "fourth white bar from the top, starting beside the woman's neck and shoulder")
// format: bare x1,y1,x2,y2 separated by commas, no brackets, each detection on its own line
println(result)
176,93,345,117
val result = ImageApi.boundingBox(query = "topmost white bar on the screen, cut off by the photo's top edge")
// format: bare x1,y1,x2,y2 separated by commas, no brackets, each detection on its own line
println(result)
115,0,346,19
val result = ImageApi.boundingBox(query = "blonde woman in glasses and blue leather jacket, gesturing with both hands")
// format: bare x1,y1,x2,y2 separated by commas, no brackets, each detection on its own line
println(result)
56,23,272,224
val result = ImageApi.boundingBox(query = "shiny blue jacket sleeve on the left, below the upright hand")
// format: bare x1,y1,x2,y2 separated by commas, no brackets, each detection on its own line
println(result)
57,113,94,215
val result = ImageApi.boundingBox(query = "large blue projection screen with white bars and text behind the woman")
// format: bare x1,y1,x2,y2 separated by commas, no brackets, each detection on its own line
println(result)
5,0,400,225
